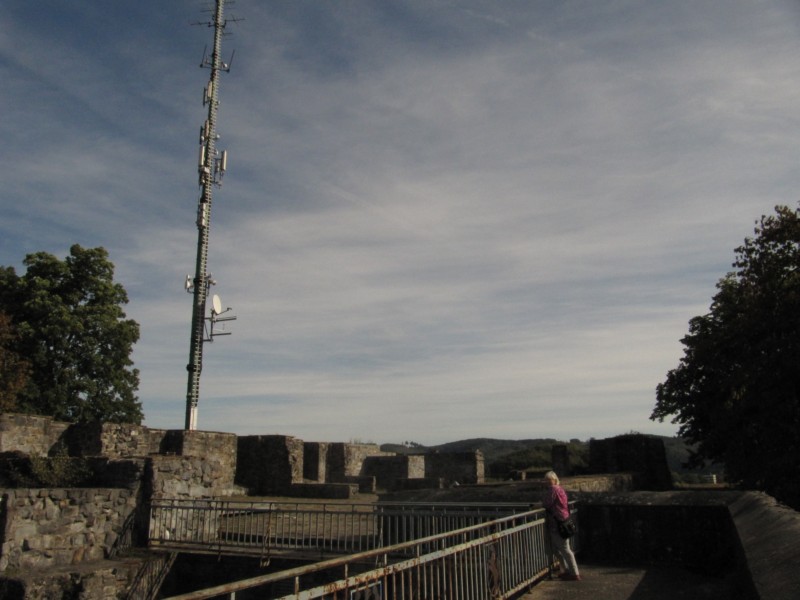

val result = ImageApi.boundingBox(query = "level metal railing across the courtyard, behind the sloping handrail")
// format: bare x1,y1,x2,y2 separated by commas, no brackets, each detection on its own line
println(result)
149,499,528,559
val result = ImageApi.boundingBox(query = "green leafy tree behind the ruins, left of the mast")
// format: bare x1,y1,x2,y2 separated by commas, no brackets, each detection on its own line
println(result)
0,245,143,423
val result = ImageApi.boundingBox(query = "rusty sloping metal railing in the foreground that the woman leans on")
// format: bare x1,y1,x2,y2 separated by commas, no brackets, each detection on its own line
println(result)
161,509,568,600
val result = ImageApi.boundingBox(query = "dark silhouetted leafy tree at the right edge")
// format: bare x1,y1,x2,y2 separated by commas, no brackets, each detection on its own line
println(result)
651,206,800,508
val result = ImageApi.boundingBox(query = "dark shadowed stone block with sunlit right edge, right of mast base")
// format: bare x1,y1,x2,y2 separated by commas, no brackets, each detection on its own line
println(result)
235,435,303,496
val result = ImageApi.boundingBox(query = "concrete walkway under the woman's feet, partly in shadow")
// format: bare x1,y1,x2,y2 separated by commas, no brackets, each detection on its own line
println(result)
520,564,731,600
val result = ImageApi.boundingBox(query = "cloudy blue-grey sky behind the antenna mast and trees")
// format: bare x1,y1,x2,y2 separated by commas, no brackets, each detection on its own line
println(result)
0,0,800,445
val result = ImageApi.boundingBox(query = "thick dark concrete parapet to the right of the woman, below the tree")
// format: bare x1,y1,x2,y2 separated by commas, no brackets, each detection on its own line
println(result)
575,491,800,600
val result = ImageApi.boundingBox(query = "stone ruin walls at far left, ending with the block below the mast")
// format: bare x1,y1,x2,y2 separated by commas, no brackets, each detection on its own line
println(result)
0,414,243,572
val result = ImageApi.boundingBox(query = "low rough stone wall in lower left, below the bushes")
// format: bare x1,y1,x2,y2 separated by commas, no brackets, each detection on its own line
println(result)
0,489,136,572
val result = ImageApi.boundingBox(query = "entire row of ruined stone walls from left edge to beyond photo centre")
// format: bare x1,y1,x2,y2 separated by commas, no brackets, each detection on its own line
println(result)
0,414,504,571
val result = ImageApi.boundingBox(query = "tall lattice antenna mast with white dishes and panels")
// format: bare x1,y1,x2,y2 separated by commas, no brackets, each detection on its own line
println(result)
186,0,235,430
